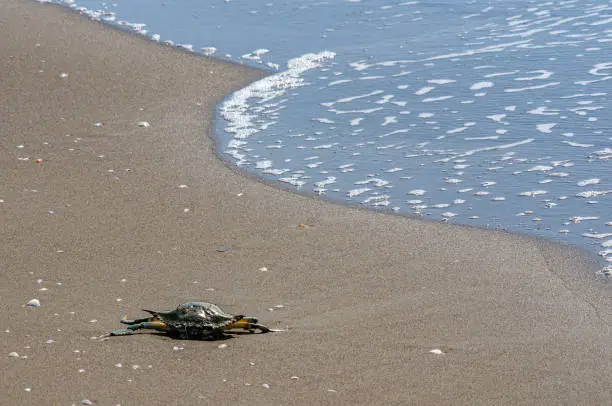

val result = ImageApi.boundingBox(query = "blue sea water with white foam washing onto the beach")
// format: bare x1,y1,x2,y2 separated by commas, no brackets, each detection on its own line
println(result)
44,0,612,276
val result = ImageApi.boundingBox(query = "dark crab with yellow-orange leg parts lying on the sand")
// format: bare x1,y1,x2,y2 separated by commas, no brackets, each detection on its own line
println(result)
109,302,276,340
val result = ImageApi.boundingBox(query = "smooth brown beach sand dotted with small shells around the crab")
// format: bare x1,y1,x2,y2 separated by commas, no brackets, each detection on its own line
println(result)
0,0,612,405
